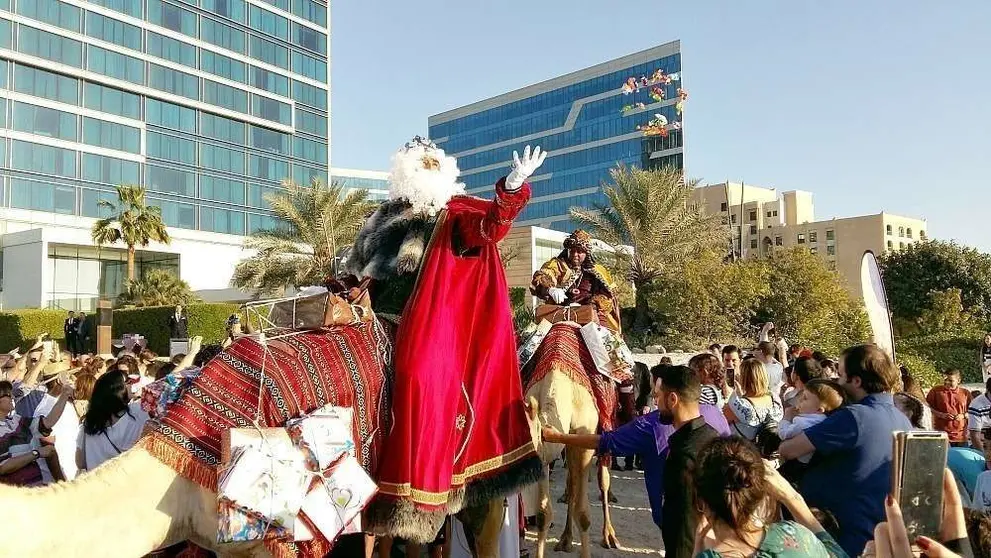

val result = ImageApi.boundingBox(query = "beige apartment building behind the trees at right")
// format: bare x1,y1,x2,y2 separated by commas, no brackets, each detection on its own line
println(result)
694,182,928,296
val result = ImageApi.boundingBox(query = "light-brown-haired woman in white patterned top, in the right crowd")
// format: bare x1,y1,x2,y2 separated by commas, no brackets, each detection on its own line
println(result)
723,358,784,441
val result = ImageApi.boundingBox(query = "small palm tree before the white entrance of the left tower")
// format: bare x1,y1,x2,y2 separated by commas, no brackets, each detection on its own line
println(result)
92,185,169,281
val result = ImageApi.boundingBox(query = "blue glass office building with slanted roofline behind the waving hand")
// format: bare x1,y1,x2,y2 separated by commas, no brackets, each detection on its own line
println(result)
428,41,684,231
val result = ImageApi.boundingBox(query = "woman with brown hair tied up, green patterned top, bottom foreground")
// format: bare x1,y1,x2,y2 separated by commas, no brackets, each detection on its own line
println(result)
694,437,847,558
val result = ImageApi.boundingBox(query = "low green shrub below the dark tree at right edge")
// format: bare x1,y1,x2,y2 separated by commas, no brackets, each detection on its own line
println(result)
895,331,984,383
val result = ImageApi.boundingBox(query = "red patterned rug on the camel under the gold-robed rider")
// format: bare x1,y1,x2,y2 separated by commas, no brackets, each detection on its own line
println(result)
522,323,618,430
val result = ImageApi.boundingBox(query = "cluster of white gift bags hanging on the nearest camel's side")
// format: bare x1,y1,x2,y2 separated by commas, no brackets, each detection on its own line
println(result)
217,405,377,542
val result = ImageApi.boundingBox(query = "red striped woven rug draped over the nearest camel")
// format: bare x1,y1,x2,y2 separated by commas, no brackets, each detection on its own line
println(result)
139,323,394,557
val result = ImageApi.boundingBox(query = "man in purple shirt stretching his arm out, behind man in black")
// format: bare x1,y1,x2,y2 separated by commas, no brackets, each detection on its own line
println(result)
541,364,730,527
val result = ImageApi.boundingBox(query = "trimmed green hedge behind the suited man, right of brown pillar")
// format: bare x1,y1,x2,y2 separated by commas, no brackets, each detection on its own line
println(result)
113,303,243,355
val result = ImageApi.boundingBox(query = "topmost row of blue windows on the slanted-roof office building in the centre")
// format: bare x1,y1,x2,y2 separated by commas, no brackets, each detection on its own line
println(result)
430,53,681,138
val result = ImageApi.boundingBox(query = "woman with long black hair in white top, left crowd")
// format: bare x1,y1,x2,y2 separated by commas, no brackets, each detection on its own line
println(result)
76,371,148,470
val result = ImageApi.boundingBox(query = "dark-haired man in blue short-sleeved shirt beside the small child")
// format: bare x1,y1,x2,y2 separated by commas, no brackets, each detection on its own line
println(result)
779,345,912,556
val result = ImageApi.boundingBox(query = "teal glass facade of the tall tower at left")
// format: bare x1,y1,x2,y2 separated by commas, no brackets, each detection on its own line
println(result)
0,0,330,235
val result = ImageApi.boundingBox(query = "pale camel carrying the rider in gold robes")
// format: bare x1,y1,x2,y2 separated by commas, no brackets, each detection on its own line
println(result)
525,370,619,558
